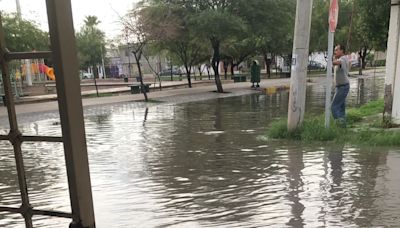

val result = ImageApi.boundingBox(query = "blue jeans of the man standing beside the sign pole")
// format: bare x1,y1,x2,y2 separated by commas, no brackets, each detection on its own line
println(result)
331,84,350,122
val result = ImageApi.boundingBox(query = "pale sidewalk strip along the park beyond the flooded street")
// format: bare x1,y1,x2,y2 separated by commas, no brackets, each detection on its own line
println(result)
0,78,290,117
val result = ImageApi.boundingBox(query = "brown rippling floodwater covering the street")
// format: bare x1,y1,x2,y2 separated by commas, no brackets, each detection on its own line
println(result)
0,76,400,228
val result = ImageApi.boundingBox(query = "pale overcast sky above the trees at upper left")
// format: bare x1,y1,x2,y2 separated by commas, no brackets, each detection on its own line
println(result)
0,0,137,39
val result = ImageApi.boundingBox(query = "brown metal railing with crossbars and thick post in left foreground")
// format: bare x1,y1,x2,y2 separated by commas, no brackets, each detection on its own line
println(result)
0,0,95,228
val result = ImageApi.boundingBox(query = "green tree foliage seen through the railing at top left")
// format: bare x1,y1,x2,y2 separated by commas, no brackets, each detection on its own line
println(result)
2,14,50,52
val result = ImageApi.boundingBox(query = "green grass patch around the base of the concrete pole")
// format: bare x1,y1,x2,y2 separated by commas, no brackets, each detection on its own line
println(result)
267,100,400,146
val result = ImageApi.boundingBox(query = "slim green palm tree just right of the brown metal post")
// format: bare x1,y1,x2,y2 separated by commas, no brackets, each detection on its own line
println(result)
76,16,105,78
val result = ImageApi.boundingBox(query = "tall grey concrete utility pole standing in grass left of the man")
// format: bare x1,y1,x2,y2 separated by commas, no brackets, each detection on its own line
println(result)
288,0,313,131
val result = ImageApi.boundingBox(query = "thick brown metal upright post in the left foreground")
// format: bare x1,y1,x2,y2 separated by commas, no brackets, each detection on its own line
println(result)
46,0,95,228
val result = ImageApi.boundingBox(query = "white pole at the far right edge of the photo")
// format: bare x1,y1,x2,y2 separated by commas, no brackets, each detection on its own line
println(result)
384,0,400,123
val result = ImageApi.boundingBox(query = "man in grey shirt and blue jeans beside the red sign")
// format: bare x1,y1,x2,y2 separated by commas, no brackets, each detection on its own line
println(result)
331,45,350,127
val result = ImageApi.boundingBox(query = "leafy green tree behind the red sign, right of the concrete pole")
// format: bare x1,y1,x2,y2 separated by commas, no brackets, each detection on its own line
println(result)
310,0,390,74
